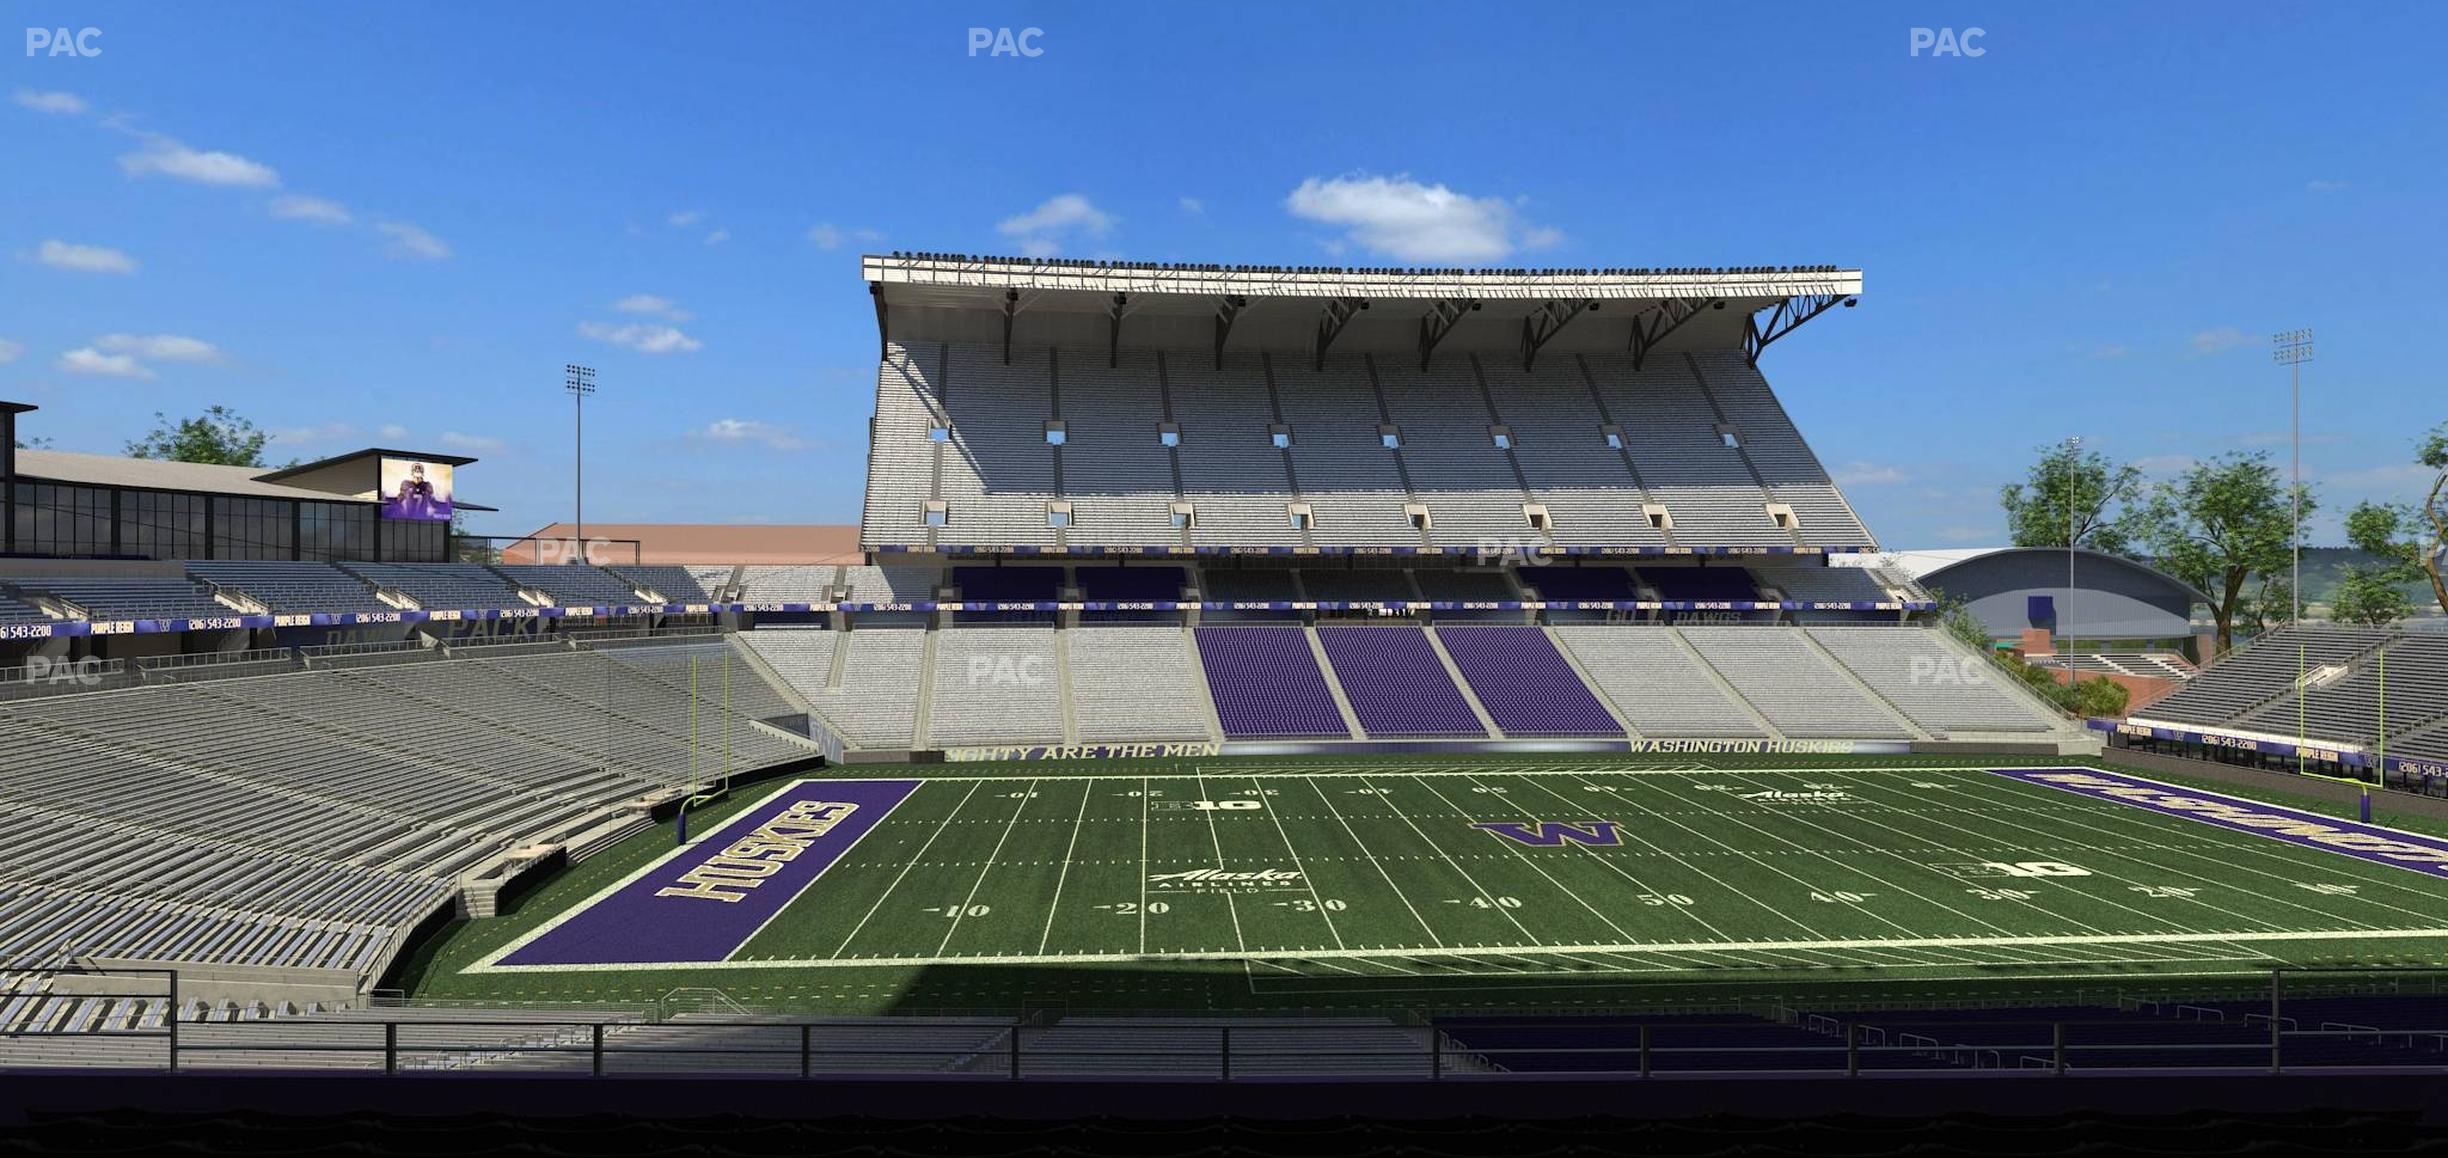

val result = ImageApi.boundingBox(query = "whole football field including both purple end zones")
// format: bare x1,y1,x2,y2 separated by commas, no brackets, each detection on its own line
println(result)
455,761,2448,994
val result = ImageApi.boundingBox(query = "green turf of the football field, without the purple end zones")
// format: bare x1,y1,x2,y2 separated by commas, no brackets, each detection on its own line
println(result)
391,756,2448,1011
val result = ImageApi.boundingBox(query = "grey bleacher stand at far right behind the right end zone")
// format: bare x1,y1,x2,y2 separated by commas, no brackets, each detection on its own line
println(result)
2140,627,2448,759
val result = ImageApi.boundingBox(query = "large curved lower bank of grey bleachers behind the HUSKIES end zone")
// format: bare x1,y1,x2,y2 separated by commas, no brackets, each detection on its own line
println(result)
0,639,818,984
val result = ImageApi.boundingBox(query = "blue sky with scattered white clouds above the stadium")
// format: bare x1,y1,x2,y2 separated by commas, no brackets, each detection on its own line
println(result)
0,0,2448,548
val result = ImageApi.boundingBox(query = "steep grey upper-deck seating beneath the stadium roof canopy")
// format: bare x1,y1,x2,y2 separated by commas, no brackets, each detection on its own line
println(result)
862,343,1873,551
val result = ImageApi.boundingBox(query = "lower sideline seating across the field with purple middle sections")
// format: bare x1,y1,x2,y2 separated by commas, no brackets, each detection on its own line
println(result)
739,622,2069,752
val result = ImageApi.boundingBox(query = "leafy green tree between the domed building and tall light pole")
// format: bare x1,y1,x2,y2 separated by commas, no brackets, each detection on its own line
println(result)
2140,453,2316,651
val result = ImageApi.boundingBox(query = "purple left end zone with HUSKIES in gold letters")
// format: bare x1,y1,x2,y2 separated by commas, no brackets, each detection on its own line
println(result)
499,781,920,965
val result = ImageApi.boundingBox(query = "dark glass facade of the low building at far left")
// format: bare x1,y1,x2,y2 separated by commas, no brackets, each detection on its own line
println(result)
7,480,450,563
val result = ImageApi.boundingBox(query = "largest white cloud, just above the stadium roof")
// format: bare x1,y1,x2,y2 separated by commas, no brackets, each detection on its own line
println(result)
1283,174,1564,264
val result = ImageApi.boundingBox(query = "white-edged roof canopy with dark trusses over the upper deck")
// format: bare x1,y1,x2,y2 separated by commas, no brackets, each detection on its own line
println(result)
862,252,1860,369
